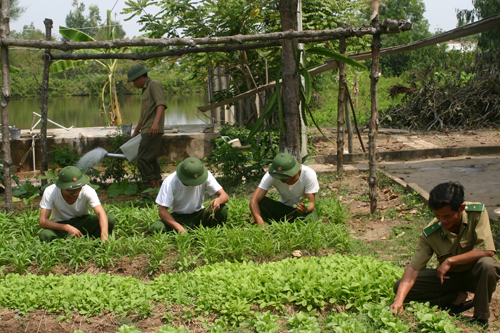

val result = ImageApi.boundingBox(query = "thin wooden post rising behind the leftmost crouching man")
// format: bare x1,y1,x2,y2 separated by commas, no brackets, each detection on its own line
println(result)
40,19,52,186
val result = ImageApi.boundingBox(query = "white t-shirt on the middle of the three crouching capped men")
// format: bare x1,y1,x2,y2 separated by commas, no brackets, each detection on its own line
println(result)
156,171,222,214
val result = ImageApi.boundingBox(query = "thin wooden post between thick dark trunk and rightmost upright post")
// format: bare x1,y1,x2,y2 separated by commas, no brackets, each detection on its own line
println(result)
337,38,347,176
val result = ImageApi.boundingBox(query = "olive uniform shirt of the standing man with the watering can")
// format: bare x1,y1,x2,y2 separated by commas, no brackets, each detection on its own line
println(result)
141,78,167,134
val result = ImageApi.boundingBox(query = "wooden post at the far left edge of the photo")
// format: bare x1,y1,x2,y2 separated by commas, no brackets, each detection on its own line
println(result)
0,1,14,213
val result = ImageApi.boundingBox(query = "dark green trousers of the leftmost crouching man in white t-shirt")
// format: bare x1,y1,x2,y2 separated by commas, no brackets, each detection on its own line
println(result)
38,214,116,242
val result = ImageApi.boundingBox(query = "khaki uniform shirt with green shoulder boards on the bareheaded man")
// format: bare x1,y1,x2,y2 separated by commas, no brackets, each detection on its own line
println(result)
410,202,495,272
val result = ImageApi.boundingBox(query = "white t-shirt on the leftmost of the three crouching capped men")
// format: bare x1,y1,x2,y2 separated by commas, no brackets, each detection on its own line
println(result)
40,184,101,222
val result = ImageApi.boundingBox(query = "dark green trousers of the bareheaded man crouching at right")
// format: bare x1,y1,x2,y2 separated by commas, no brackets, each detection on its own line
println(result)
394,257,500,319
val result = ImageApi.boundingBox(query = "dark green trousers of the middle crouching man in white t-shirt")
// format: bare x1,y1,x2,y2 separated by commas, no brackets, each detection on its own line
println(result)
149,204,228,234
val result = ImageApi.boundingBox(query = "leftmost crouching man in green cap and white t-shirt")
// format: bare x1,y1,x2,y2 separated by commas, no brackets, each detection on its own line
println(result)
39,166,115,241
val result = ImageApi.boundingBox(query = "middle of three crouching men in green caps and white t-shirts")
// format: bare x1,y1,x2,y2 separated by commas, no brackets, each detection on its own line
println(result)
149,157,229,233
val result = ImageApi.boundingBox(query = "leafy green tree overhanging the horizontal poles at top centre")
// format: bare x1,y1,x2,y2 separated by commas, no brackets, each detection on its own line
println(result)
122,0,362,155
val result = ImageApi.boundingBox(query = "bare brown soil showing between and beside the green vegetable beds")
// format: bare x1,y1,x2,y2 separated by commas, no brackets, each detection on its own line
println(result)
0,130,500,333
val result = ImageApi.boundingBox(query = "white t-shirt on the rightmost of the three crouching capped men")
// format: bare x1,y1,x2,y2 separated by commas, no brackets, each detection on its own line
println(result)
259,165,319,207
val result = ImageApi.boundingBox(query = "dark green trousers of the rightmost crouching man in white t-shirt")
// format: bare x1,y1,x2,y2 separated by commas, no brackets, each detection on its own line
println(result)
259,197,319,222
